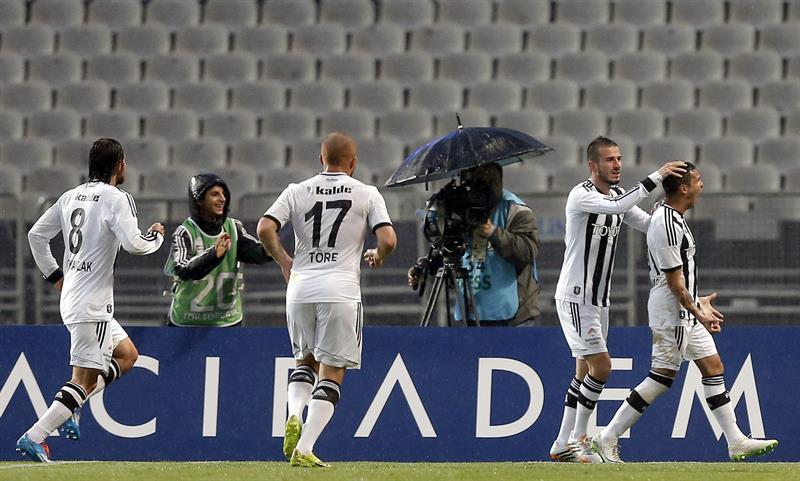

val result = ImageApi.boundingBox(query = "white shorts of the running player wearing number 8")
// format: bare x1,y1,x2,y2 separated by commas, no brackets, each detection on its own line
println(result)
66,319,128,372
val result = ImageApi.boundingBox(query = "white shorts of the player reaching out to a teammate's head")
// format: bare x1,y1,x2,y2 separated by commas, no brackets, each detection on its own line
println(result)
556,299,608,359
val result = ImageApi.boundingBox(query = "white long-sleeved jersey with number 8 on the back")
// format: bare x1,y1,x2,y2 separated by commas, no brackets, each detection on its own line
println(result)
28,182,164,324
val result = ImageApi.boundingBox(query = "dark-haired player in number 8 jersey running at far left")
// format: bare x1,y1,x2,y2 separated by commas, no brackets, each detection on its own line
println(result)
17,138,164,463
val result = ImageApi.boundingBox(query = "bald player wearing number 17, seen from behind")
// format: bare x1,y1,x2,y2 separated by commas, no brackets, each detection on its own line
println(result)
258,133,397,467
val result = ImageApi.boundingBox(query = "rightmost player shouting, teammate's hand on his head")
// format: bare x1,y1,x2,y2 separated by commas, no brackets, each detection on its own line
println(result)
592,163,778,463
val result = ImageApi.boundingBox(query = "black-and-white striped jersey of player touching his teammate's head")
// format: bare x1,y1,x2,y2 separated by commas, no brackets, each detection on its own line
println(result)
555,171,662,307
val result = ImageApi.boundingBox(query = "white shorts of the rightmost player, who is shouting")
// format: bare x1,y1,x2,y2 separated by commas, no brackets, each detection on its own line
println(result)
650,322,717,371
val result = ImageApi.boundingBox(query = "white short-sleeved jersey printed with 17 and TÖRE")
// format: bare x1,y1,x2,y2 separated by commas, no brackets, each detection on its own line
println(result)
264,172,392,303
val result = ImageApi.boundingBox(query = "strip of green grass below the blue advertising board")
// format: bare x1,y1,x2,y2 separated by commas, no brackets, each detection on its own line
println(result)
0,462,800,481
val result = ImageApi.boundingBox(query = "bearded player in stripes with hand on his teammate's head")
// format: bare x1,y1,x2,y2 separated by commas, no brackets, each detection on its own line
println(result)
550,136,683,463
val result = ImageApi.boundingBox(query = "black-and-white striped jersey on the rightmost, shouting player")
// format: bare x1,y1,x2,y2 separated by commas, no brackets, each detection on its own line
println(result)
647,204,698,326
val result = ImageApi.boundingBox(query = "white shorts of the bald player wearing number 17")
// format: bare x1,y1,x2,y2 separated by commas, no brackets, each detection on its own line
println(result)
286,301,364,369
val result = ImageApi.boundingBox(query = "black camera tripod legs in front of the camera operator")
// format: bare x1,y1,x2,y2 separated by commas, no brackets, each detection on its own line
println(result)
419,257,480,327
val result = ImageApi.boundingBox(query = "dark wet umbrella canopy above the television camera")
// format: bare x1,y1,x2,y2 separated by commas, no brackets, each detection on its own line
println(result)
386,126,553,187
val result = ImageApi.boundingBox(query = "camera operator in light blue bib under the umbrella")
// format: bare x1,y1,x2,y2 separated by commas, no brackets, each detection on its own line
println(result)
408,163,539,326
